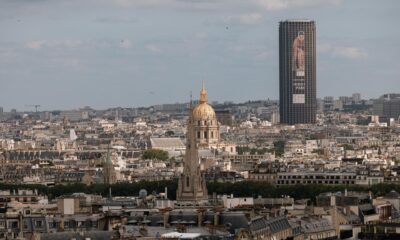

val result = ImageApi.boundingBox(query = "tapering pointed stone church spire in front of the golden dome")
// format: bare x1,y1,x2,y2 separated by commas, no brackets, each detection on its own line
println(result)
176,87,208,203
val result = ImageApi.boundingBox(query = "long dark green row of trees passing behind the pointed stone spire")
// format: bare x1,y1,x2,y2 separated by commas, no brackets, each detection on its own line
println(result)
0,179,400,202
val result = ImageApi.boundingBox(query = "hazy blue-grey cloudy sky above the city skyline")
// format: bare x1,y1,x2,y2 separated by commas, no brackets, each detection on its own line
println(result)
0,0,400,111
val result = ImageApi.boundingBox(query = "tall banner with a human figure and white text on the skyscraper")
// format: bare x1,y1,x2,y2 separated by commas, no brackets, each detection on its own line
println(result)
292,31,306,104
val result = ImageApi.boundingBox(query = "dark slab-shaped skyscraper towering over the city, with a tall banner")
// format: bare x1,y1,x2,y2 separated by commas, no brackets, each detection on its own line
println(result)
279,20,317,125
